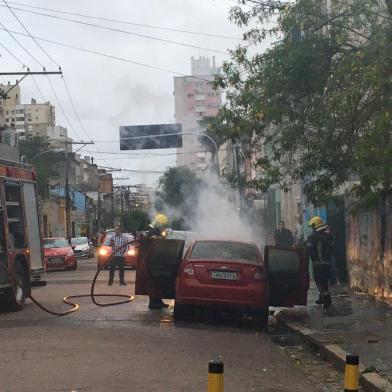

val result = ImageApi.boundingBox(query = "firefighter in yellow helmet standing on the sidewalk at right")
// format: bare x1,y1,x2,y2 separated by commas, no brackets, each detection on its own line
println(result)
307,216,334,308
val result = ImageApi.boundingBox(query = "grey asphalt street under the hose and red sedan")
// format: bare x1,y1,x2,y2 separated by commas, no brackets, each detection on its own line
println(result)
0,259,348,392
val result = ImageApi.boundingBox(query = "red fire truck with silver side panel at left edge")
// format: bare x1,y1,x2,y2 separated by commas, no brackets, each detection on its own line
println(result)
0,158,44,311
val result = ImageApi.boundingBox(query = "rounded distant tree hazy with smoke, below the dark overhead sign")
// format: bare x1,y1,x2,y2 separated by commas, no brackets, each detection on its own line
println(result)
155,167,202,230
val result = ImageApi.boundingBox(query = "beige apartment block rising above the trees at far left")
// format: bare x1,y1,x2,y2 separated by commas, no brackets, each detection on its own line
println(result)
15,99,56,138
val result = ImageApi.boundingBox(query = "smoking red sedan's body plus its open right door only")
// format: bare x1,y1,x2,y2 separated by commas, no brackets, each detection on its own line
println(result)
174,241,309,329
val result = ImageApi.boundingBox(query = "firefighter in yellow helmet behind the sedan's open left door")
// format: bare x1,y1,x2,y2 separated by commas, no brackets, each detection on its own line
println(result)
148,213,169,309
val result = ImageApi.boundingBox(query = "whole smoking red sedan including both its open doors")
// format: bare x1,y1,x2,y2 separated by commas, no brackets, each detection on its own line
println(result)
135,238,309,329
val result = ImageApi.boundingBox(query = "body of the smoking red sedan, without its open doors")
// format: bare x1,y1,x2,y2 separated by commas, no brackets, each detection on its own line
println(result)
174,241,270,325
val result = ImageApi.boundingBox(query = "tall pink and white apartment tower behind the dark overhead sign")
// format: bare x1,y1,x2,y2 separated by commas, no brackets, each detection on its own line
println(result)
174,57,221,171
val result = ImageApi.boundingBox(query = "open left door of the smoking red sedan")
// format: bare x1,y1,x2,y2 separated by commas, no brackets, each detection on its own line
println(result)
135,237,185,299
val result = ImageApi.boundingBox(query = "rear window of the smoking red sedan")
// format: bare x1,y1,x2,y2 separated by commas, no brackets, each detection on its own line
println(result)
189,241,259,263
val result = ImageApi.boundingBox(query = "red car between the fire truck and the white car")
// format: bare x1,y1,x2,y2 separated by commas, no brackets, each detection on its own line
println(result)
44,237,77,271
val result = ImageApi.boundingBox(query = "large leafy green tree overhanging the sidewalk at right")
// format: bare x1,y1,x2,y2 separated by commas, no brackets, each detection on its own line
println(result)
213,0,392,204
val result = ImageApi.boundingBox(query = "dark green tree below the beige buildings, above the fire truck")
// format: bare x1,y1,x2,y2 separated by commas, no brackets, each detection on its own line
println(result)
19,136,63,199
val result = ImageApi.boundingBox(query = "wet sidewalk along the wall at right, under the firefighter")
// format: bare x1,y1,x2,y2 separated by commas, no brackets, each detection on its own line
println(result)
276,285,392,391
